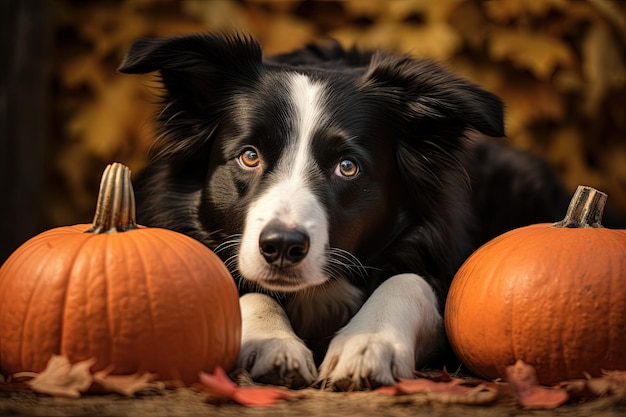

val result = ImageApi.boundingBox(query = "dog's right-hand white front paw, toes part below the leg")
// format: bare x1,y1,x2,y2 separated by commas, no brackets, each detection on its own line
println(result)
319,332,415,391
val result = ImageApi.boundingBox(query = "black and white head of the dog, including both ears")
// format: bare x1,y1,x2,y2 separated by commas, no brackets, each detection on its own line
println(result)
120,35,504,292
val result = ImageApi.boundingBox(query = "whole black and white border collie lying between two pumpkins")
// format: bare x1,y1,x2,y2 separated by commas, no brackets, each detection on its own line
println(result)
119,34,566,389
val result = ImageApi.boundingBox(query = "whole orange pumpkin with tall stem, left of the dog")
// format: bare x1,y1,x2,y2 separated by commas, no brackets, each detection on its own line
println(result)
0,164,241,383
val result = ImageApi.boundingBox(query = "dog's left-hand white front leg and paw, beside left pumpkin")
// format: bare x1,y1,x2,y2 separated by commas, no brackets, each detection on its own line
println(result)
237,293,317,388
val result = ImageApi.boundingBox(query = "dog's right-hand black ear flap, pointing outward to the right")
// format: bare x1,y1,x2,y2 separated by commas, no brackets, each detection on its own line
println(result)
365,55,505,137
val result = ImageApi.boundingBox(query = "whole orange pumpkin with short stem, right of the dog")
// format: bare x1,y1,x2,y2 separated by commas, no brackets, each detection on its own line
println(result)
445,187,626,384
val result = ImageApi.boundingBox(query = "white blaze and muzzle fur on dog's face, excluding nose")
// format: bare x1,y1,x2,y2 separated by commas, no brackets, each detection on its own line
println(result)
238,74,328,291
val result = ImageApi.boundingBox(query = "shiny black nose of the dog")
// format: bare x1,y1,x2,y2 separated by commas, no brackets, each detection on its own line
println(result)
259,221,309,268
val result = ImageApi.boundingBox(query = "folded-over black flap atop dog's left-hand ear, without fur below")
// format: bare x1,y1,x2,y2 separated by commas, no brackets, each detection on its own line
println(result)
118,34,262,95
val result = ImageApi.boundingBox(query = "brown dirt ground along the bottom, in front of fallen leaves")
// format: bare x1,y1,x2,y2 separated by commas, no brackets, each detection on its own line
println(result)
0,388,626,417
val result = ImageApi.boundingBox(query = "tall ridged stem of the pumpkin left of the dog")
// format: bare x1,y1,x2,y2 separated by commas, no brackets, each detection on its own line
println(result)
85,162,137,234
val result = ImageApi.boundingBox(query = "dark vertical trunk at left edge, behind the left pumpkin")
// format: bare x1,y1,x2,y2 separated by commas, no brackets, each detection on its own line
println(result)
0,0,52,263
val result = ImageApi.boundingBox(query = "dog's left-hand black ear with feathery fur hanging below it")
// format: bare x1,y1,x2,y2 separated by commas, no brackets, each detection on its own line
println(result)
118,34,263,163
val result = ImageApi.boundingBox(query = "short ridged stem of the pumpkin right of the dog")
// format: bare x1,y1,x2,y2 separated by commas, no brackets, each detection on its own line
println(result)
552,185,607,228
